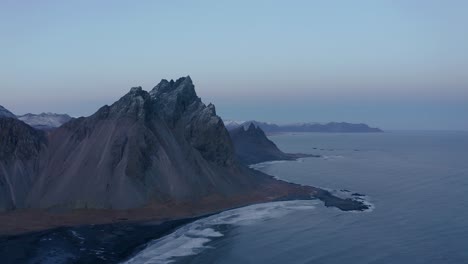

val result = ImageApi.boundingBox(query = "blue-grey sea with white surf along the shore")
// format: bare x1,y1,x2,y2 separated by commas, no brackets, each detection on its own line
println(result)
124,132,468,264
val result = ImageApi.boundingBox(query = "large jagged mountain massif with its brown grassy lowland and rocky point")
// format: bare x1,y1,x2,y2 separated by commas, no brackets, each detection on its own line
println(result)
0,77,366,235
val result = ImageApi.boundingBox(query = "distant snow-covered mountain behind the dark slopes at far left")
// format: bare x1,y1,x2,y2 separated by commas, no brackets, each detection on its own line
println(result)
18,113,72,130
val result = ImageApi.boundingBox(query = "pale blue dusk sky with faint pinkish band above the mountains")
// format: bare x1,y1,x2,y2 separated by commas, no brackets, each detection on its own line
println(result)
0,0,468,130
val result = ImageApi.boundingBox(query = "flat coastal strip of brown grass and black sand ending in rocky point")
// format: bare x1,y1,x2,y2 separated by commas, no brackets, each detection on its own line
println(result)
0,180,368,263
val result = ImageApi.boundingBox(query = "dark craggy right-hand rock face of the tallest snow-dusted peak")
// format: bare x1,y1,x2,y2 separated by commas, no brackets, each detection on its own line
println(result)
150,77,235,166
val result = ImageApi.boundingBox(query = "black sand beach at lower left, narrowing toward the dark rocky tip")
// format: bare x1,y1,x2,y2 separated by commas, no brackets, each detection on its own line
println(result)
0,193,366,263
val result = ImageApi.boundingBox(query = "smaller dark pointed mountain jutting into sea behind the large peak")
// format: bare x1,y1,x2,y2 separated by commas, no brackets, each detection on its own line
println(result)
229,123,315,165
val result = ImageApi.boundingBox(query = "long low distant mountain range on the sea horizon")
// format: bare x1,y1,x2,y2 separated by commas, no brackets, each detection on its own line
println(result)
224,120,383,134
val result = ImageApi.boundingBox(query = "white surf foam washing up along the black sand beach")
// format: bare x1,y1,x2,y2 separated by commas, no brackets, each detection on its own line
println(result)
125,200,319,264
